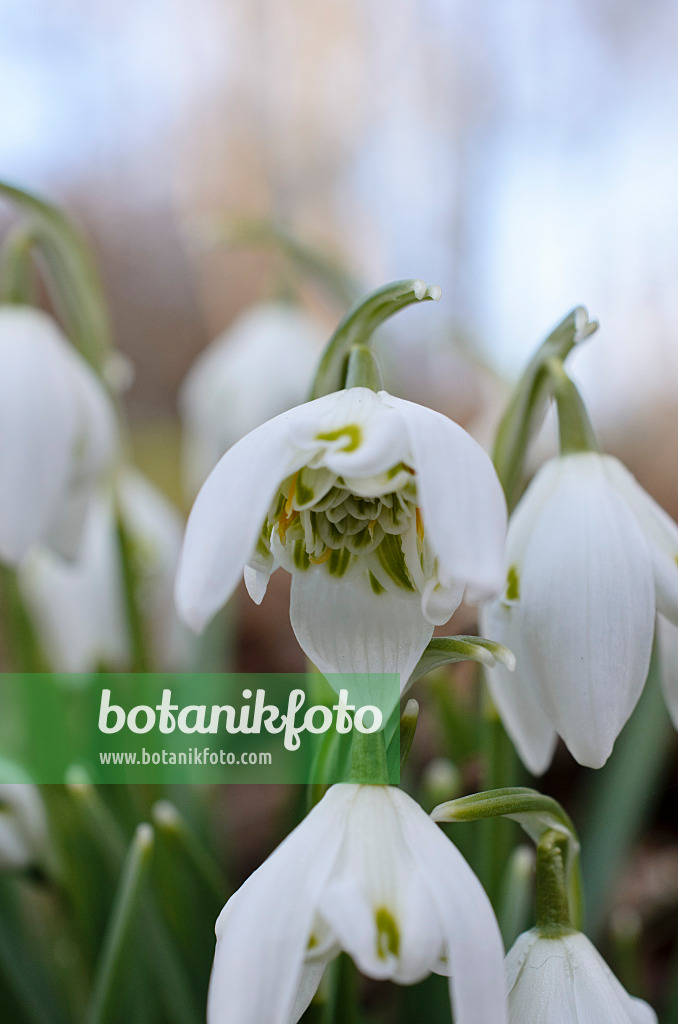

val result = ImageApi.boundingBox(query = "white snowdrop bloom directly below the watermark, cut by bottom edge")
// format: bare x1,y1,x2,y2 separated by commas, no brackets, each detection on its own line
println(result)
207,784,506,1024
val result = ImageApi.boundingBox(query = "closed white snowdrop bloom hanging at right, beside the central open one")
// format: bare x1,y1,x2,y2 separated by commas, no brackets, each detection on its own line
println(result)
481,453,678,774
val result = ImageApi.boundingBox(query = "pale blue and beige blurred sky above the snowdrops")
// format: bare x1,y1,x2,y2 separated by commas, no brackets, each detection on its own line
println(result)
0,0,678,418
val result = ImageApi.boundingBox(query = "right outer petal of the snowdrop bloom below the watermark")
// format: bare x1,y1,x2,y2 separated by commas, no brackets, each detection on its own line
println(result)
399,790,507,1024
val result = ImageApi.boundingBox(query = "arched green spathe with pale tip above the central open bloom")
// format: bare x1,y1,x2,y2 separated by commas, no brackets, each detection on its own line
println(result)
309,281,440,398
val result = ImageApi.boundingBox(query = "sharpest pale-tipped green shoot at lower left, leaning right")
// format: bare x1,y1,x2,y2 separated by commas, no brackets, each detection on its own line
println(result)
86,824,153,1024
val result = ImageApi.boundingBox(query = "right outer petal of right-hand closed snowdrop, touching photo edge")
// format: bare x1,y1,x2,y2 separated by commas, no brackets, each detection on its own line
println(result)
605,456,678,626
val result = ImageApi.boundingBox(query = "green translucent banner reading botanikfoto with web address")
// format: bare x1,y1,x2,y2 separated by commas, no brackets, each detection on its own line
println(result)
0,673,399,784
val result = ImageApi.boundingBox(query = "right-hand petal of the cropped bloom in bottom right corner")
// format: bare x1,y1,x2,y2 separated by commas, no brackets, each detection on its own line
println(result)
565,932,656,1024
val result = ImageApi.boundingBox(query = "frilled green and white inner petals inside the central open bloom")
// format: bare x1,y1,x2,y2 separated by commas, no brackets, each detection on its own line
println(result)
258,463,423,591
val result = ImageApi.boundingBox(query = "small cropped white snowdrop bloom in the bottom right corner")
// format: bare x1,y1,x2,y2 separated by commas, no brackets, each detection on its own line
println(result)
506,928,656,1024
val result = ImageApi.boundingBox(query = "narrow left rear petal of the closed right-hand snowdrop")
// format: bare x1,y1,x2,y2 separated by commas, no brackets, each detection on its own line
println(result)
480,600,558,775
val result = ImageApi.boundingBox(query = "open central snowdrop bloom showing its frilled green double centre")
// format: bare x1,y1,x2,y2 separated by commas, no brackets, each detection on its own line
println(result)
176,387,506,683
